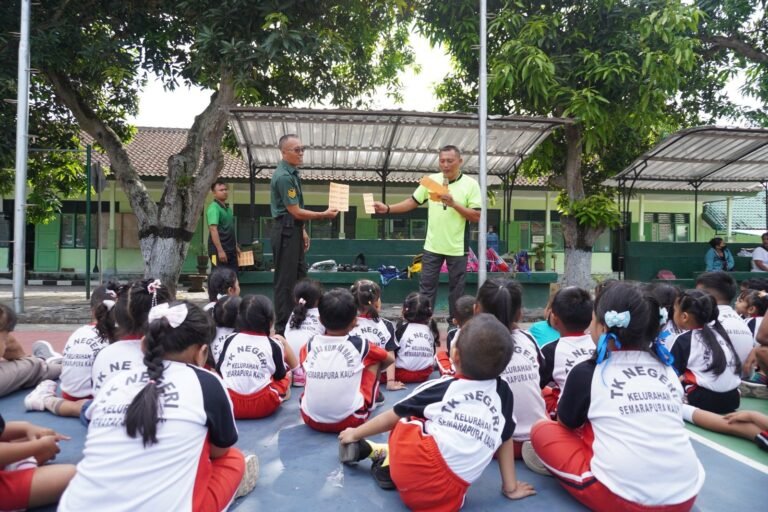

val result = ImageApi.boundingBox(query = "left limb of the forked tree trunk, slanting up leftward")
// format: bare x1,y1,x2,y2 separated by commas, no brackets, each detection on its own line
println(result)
42,68,157,227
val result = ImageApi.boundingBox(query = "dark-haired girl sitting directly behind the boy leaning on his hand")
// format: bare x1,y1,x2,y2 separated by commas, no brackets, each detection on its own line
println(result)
477,278,547,459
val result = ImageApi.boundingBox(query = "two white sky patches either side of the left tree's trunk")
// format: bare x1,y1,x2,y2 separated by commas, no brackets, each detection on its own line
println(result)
132,35,450,128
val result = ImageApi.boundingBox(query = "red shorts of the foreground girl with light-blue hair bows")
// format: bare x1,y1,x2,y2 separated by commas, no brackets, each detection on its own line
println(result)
531,420,696,512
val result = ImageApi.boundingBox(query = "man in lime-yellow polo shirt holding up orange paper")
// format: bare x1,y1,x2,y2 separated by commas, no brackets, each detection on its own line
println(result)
373,146,482,318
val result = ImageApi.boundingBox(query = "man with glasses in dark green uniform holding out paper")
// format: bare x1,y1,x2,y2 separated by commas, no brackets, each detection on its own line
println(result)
269,134,339,335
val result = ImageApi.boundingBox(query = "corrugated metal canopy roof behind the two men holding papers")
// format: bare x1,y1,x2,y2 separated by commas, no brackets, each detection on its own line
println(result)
225,107,568,186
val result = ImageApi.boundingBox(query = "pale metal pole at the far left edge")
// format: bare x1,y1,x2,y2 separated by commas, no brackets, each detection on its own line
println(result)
13,0,31,313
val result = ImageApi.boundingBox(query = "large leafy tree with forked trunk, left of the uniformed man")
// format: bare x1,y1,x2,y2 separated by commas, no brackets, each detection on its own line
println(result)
4,0,412,287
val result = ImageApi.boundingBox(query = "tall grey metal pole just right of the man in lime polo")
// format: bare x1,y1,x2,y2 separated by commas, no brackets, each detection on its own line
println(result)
477,0,488,288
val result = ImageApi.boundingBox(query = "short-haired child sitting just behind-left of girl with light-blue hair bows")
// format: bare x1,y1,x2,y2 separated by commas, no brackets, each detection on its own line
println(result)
541,286,595,418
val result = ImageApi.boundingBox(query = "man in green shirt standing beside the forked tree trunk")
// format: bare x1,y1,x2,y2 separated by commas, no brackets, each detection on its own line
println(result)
205,179,240,273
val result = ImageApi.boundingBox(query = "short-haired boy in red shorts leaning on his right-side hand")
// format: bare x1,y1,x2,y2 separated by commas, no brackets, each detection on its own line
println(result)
339,314,535,510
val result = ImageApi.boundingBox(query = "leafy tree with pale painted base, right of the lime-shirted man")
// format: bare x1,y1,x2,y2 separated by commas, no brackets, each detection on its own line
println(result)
420,0,700,286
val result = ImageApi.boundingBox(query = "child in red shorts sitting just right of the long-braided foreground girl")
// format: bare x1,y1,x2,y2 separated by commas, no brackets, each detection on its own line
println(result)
216,295,298,419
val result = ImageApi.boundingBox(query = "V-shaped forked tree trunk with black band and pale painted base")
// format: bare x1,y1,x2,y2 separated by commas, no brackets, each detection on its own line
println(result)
45,70,234,295
